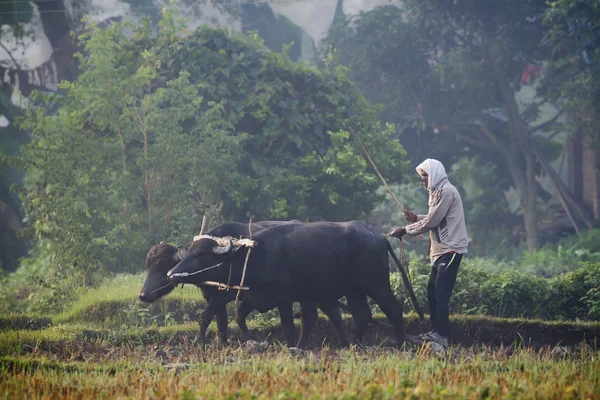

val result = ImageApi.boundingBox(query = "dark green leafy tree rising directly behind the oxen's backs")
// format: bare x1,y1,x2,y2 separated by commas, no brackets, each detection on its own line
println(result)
166,23,404,220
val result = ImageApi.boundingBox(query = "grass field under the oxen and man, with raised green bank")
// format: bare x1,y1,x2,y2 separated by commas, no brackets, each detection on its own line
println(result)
0,278,600,399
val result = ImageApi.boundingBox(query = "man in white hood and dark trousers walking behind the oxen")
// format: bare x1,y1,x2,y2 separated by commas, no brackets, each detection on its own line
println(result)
390,158,468,347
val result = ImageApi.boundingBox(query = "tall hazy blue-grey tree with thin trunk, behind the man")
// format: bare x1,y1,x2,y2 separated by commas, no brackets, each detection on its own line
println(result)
326,0,584,251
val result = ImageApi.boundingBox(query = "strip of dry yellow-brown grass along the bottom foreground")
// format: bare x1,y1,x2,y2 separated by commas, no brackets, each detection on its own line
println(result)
0,343,600,399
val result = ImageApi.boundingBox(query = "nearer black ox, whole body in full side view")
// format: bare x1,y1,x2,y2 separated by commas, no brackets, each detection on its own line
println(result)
167,221,421,346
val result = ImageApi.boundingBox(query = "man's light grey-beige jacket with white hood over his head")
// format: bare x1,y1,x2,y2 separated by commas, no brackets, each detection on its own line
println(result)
406,158,469,264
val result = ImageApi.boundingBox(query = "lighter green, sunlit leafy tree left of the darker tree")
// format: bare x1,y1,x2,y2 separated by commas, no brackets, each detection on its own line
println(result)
22,14,243,278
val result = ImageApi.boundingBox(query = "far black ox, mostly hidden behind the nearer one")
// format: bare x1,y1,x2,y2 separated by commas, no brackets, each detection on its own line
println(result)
139,221,356,348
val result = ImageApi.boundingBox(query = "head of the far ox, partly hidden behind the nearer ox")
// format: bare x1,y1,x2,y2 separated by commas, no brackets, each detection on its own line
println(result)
139,242,185,303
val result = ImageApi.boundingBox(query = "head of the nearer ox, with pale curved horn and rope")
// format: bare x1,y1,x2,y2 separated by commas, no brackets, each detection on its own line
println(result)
167,237,239,283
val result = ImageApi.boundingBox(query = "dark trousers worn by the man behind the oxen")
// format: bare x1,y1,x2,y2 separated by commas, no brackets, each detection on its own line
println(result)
427,253,462,336
